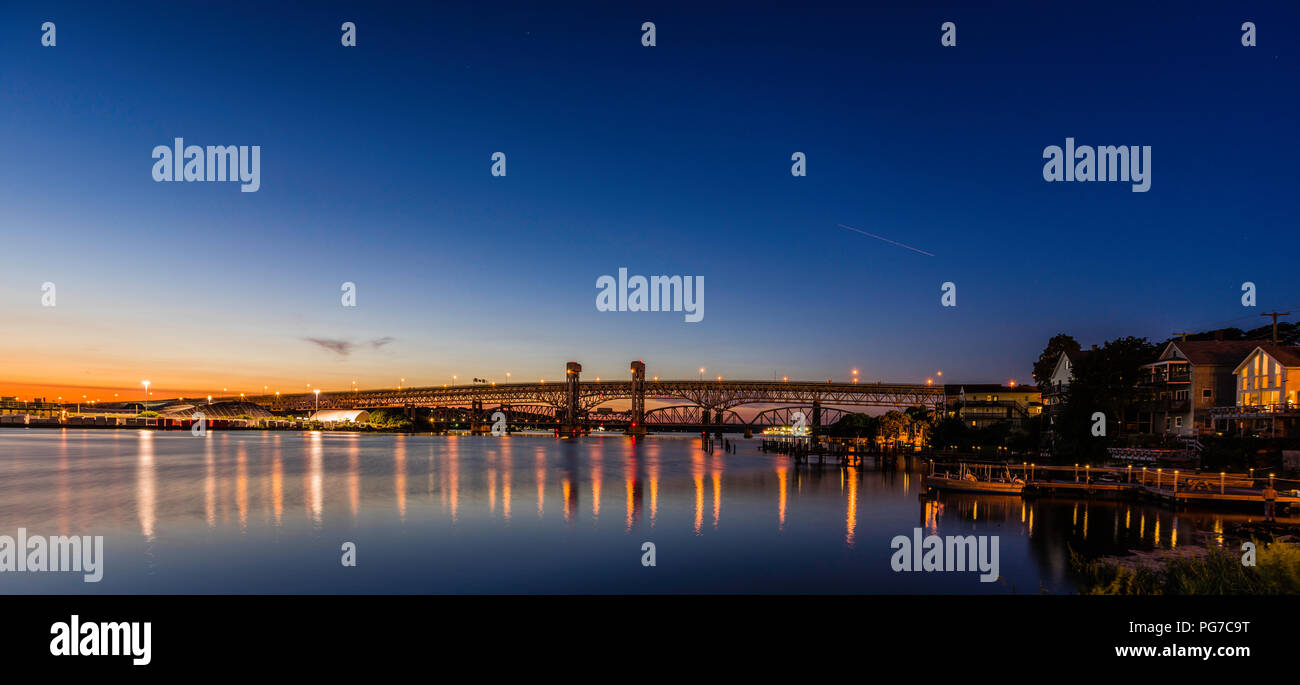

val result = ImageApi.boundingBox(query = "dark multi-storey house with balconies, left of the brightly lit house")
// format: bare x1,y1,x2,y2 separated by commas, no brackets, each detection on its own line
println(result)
1138,341,1260,438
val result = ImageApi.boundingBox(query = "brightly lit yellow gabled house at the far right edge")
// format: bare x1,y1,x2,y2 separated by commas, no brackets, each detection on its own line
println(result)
1214,343,1300,438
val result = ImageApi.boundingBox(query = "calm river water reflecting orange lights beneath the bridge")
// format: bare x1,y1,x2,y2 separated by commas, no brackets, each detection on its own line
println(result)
0,429,1279,593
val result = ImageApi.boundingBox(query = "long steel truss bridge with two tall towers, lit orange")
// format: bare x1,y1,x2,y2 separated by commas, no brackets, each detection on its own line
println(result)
220,361,944,434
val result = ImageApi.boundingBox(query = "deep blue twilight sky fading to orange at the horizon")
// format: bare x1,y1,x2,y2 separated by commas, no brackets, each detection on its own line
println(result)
0,3,1300,394
